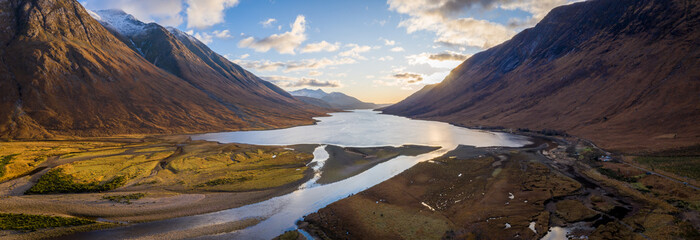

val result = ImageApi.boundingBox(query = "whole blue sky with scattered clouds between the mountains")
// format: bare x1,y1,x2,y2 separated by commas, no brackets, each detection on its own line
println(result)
80,0,573,103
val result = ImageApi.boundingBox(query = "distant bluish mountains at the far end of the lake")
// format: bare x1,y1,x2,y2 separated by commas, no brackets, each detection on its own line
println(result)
290,88,380,110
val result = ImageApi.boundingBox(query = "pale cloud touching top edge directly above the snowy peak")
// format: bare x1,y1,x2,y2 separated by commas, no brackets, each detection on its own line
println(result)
81,0,183,26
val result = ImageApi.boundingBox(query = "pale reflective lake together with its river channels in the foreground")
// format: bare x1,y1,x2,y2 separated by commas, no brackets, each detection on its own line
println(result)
72,110,529,239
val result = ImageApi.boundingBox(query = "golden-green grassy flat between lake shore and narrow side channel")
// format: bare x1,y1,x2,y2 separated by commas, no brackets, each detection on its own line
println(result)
156,144,313,191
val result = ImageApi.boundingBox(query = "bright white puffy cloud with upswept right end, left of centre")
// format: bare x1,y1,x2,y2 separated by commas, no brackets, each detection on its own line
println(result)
238,15,306,55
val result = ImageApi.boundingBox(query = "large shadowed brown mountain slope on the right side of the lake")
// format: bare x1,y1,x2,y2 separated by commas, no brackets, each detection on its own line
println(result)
384,0,700,151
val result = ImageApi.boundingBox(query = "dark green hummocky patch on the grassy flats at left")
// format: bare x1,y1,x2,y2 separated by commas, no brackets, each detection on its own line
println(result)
26,168,127,194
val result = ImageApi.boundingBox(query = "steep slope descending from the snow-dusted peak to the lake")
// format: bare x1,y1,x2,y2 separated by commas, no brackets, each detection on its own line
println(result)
97,10,322,127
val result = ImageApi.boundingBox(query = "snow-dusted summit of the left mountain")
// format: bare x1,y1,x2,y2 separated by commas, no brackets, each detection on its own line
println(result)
90,9,148,36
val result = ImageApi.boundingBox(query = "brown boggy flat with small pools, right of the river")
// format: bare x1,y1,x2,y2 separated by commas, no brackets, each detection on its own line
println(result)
298,139,700,239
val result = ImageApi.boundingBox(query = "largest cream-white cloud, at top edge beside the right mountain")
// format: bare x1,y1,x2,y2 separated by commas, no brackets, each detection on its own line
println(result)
388,0,569,49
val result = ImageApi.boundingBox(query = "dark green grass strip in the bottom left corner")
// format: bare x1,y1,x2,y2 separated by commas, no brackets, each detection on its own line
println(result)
0,213,95,231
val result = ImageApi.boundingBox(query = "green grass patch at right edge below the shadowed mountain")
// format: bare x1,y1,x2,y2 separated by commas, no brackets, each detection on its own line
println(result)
635,156,700,181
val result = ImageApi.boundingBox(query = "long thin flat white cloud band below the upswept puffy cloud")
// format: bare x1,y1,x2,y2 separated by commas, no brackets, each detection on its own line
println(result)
233,58,355,72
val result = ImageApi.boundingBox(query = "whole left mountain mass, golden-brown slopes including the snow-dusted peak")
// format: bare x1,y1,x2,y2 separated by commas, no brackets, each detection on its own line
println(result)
0,0,323,138
